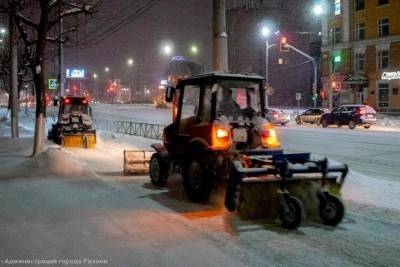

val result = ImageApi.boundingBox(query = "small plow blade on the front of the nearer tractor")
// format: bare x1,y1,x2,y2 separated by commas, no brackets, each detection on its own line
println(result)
124,150,154,175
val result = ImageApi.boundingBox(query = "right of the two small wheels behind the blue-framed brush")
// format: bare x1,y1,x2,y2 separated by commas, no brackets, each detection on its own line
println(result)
319,193,344,226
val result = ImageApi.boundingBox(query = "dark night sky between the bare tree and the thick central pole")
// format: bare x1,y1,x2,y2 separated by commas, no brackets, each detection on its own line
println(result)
65,0,212,86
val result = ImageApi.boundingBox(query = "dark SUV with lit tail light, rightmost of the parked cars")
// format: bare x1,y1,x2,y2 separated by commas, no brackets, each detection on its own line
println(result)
320,105,376,129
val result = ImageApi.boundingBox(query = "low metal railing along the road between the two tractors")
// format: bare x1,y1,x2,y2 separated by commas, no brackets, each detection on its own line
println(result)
94,119,165,140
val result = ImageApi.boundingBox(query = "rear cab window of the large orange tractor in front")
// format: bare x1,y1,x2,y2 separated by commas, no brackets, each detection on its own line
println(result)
217,80,260,121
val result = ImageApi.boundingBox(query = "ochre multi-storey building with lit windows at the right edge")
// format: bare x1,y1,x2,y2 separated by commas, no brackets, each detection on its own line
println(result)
321,0,400,111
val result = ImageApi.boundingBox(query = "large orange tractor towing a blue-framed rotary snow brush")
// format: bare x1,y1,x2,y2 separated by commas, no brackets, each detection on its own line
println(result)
149,72,347,229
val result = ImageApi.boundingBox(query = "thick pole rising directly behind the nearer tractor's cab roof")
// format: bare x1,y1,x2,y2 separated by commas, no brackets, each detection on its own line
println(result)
213,0,228,71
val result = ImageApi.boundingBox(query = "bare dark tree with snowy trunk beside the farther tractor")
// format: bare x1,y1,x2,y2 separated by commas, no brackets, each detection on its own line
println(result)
0,0,99,156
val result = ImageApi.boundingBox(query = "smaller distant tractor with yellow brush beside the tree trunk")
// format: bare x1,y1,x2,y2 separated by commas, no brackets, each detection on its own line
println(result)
47,96,96,148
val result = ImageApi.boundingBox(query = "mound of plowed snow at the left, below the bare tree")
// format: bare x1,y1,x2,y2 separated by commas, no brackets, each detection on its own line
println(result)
0,148,96,178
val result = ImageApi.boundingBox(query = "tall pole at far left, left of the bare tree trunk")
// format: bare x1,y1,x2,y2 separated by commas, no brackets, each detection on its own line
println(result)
9,10,19,138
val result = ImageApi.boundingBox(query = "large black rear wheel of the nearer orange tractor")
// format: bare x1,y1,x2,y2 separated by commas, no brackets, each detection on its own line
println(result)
182,153,213,203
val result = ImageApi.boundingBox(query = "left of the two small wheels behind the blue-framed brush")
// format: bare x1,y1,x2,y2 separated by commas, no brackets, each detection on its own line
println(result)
279,197,304,229
